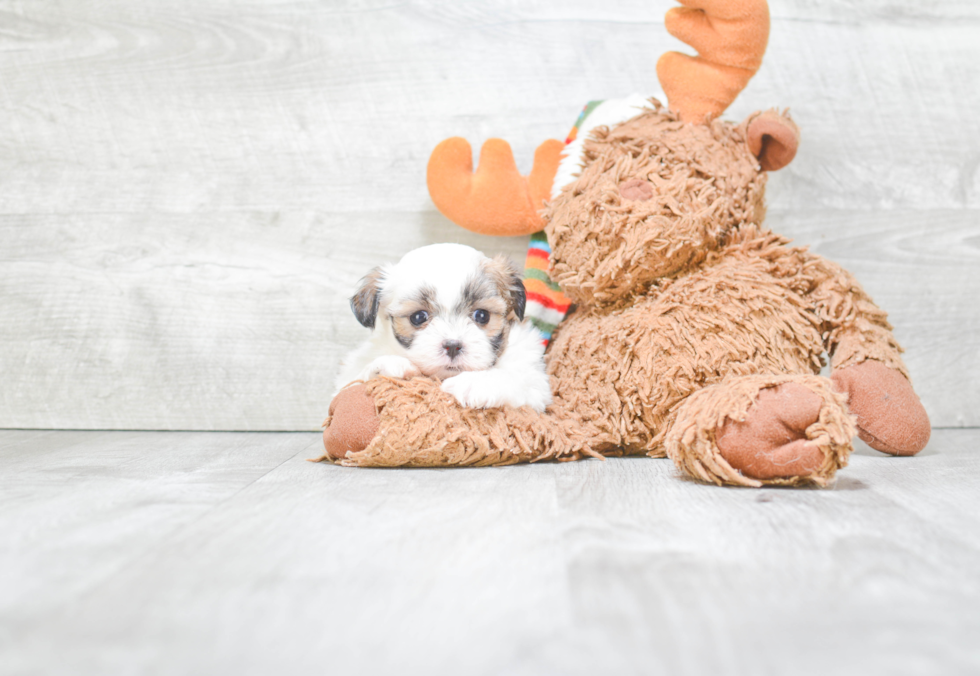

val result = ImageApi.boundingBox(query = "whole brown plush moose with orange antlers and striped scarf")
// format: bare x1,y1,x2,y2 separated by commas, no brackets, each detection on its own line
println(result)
323,0,930,486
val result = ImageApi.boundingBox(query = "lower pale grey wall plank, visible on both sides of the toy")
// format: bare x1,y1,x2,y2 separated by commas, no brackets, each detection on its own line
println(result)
0,210,980,430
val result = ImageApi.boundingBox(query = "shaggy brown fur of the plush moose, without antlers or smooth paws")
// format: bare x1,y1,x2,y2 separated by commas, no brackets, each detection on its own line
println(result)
322,105,928,486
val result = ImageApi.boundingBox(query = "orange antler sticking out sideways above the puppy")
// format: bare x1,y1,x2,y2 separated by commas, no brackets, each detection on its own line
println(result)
427,136,565,236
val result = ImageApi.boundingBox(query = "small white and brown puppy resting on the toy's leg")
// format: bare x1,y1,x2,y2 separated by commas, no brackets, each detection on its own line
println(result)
336,244,551,411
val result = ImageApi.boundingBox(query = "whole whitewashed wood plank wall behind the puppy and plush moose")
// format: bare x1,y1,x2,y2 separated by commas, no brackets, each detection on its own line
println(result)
0,0,980,430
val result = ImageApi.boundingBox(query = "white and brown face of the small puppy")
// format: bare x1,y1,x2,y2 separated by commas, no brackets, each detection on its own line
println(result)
351,244,525,378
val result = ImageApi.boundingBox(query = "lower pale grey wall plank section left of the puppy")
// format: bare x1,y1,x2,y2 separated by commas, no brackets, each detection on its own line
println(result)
0,212,526,430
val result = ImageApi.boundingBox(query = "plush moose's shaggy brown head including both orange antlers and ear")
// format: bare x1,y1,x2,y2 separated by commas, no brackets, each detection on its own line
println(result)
427,0,798,256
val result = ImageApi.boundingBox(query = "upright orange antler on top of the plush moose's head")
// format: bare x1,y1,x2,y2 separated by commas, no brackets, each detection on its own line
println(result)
657,0,769,122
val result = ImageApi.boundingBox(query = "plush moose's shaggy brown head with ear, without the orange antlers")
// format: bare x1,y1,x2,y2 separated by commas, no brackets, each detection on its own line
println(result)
544,101,797,305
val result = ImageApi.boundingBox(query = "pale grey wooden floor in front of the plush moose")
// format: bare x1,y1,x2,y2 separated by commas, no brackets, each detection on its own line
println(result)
0,429,980,676
